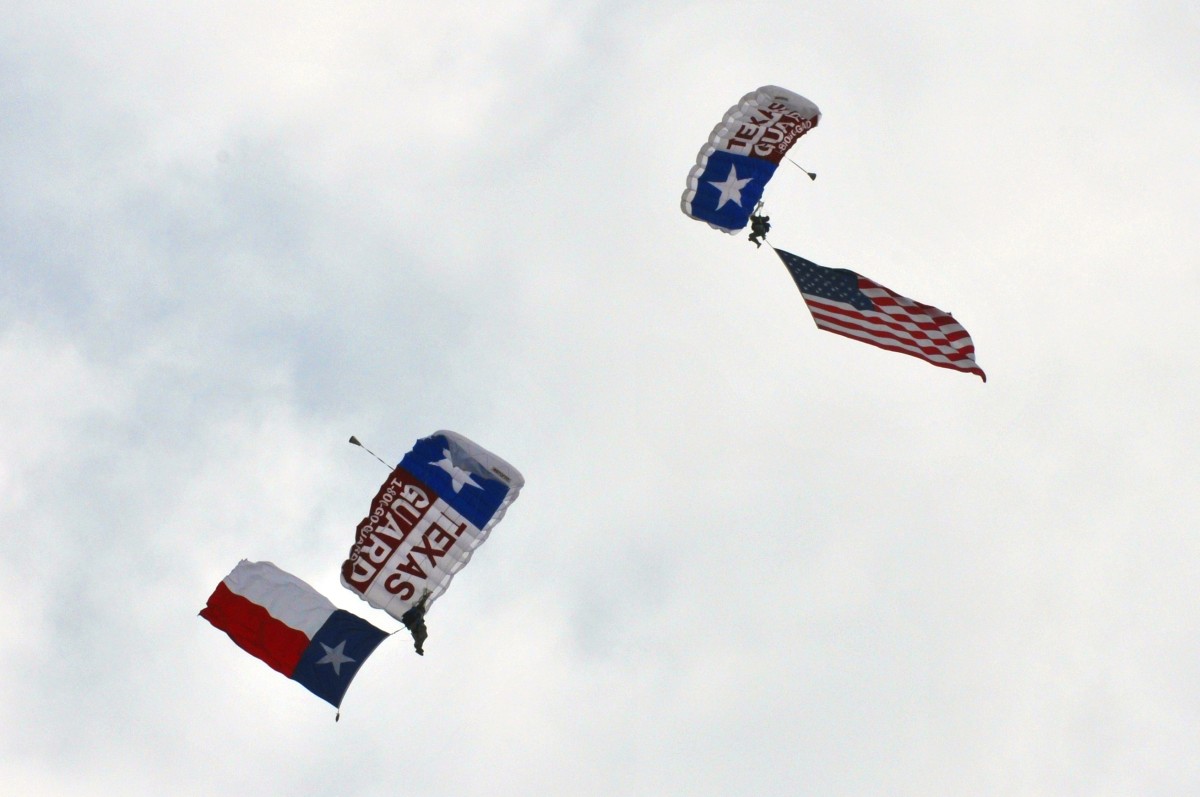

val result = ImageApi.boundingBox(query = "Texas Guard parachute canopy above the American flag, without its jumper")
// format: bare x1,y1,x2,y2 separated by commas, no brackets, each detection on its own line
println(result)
680,85,821,234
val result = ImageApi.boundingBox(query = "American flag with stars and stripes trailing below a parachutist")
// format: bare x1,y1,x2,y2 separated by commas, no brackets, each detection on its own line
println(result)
775,250,988,382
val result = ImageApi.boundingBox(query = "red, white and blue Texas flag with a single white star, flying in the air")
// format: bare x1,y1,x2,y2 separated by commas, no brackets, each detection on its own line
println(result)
200,559,388,707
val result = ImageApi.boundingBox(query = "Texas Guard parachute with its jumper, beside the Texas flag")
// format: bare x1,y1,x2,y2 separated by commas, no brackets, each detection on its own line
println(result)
342,430,524,654
